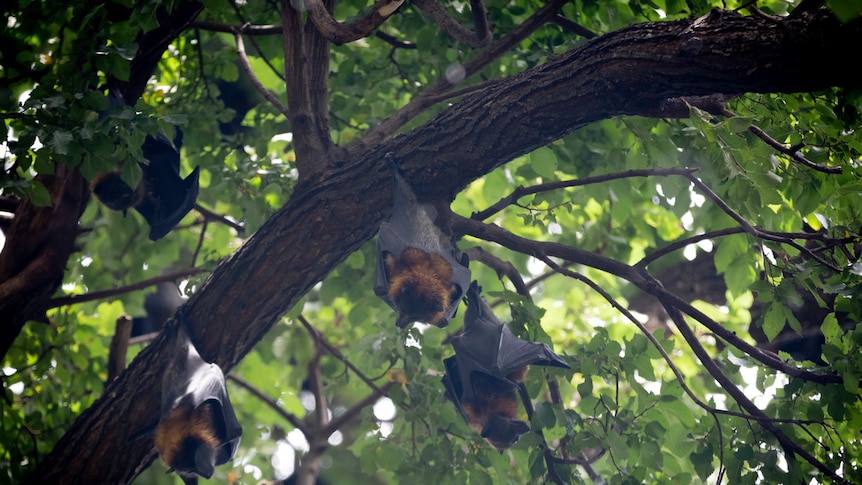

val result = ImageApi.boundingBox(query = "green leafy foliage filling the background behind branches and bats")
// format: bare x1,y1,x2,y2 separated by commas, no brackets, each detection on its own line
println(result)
0,0,862,484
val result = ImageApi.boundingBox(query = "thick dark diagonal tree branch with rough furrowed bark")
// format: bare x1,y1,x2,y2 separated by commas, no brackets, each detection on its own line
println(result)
27,7,862,483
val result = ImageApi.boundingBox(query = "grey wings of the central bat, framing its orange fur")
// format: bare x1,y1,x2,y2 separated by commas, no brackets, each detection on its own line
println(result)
374,162,471,326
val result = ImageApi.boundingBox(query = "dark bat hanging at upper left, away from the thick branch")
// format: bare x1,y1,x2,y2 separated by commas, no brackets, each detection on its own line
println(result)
90,90,200,241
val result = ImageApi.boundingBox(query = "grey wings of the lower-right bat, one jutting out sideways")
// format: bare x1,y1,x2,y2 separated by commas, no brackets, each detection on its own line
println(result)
452,283,570,400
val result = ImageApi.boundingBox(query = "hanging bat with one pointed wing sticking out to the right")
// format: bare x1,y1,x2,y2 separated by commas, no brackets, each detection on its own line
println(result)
443,283,570,453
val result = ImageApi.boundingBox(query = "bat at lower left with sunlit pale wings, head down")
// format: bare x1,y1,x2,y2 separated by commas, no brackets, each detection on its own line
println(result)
153,309,242,485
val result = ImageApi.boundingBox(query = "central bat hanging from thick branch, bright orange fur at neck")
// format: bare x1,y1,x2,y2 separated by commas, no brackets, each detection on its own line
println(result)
374,155,470,328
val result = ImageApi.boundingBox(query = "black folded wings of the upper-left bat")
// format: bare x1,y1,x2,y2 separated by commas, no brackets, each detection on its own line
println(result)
135,133,200,241
